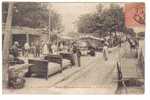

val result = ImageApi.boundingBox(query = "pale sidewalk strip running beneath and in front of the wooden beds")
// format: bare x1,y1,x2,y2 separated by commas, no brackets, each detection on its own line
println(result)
3,54,99,94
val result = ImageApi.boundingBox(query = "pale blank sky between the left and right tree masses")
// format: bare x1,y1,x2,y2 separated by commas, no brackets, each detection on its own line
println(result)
52,3,124,33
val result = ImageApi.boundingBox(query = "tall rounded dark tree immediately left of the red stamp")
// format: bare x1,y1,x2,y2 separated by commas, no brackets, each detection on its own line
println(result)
104,4,125,37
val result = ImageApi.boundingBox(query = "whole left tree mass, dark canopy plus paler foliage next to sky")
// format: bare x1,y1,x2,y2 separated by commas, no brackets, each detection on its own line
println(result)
2,2,63,32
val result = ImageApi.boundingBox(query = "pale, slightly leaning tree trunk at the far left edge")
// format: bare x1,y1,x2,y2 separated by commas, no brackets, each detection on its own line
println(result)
2,2,13,88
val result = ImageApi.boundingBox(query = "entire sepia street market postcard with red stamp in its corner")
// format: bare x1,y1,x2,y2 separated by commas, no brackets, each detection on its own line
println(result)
2,2,145,94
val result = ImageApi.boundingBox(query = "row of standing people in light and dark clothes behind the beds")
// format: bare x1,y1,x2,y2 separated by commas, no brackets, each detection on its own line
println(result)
10,41,81,58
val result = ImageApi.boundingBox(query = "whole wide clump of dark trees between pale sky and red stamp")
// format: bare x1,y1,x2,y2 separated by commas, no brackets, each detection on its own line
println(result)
77,4,125,37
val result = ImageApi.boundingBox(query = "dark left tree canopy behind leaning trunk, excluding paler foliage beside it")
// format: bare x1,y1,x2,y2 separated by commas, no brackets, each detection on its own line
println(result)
3,2,48,28
